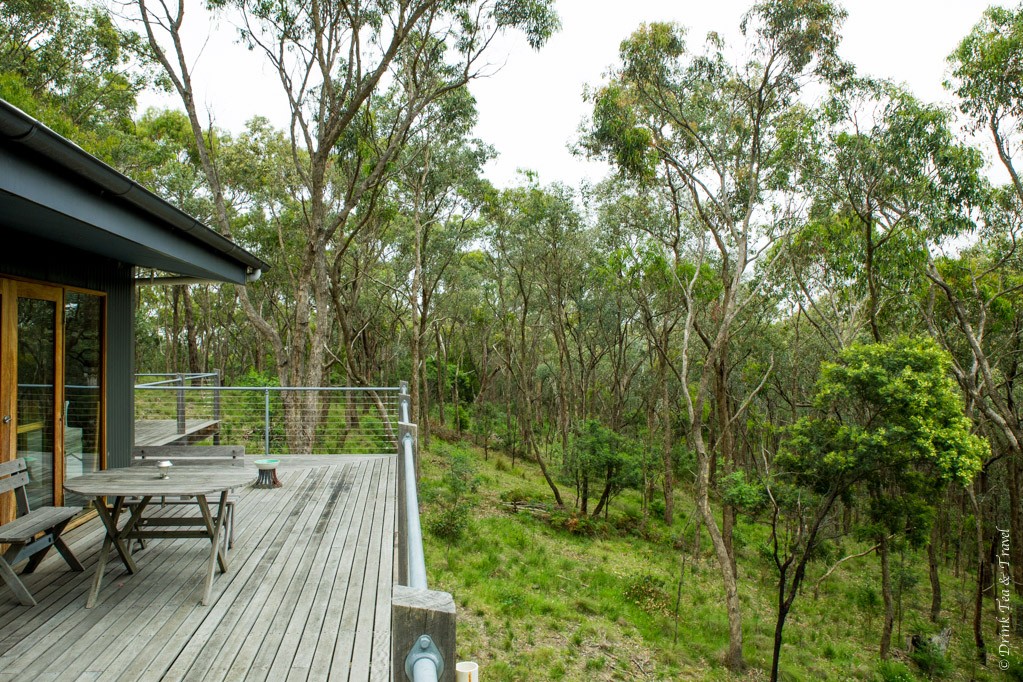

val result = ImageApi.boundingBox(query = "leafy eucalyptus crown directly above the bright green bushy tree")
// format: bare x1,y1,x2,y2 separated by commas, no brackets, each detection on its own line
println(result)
808,79,980,342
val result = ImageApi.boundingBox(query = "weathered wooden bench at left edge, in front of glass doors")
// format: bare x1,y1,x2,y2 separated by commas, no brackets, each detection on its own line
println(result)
0,459,85,606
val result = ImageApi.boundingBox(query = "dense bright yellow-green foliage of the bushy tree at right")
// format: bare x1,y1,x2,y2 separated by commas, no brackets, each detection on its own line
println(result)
782,337,988,484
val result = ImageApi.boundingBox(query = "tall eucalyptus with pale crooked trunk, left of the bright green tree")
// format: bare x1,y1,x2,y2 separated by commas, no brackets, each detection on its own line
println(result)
588,0,844,670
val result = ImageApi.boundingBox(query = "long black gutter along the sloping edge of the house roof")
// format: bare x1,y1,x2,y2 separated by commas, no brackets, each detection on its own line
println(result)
0,99,270,274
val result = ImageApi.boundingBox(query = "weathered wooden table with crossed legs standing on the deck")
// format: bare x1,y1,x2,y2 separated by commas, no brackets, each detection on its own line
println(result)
64,466,257,608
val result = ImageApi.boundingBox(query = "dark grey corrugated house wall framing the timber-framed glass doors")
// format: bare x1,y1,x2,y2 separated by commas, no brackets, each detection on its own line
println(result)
0,229,135,467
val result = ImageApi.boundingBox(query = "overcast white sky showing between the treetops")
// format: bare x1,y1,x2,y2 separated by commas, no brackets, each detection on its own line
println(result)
143,0,1007,186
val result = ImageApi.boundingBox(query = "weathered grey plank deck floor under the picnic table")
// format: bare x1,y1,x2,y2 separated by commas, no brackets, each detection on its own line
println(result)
0,455,397,682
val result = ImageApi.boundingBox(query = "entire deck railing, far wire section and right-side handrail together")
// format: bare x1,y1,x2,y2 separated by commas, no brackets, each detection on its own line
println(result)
135,373,455,682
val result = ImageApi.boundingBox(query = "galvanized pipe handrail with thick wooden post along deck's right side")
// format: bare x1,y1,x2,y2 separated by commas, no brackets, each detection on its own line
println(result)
391,383,455,682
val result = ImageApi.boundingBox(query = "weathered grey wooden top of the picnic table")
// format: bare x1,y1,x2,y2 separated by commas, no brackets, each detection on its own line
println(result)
64,465,257,497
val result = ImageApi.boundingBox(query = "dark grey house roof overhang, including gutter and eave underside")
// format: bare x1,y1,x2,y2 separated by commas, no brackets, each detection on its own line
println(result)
0,99,269,283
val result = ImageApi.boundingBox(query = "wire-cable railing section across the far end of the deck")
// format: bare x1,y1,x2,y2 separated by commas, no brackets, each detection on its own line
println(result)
135,373,399,456
